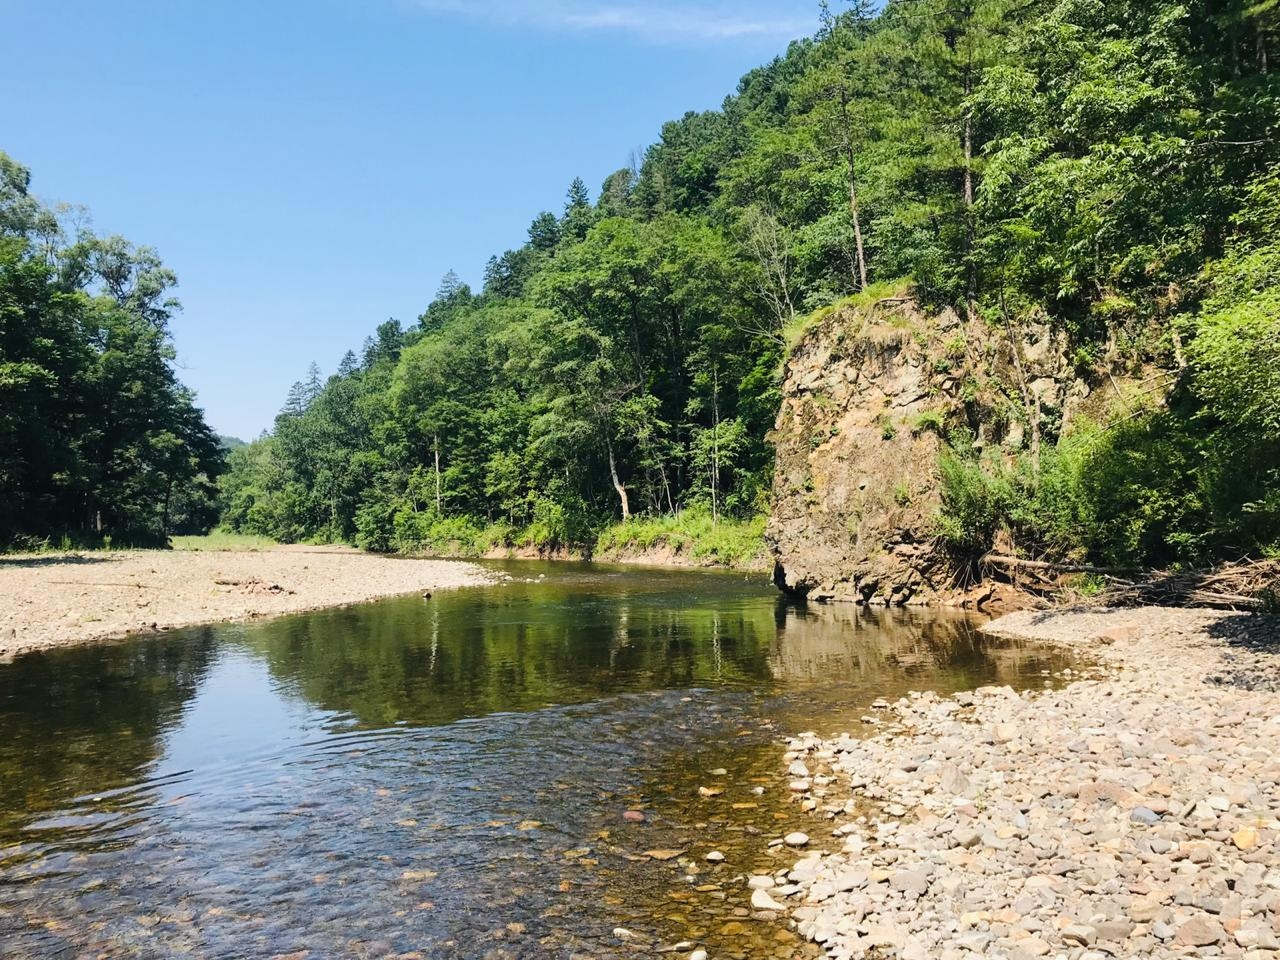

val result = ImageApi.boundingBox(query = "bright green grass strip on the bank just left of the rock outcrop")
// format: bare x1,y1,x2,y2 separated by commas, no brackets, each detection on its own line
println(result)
595,509,765,568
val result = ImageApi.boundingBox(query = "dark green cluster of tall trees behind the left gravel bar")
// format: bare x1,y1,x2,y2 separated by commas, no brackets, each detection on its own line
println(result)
0,152,223,548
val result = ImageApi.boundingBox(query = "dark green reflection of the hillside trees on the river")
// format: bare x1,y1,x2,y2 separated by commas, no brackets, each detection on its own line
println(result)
244,563,780,727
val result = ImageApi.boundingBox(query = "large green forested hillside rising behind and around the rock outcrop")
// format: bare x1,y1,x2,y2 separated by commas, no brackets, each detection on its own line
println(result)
223,0,1280,563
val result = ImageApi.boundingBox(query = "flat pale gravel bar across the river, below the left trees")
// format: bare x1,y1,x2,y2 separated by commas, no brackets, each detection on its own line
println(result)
0,547,493,657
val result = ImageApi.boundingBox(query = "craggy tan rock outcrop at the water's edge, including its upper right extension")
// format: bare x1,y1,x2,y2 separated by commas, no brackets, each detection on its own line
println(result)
765,298,1097,605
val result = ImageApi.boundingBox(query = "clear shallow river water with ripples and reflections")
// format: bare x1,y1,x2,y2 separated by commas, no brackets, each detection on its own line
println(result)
0,563,1064,960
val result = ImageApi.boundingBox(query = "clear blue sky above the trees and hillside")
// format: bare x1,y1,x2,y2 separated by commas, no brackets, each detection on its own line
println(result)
0,0,818,439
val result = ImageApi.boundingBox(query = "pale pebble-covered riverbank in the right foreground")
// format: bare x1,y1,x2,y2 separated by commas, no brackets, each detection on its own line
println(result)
751,608,1280,960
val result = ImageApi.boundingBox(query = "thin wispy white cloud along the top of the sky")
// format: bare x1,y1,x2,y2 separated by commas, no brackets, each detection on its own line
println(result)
412,0,817,44
